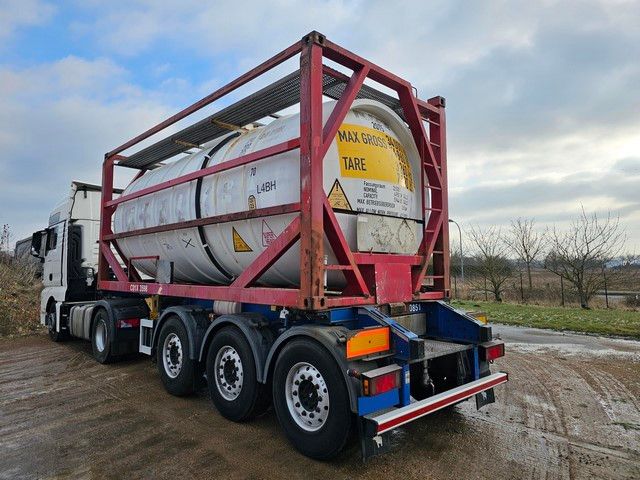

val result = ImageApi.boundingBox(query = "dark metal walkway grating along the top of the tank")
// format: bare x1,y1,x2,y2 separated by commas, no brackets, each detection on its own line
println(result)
118,69,402,169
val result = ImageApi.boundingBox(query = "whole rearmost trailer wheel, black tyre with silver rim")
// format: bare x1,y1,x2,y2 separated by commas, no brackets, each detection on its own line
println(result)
273,339,351,460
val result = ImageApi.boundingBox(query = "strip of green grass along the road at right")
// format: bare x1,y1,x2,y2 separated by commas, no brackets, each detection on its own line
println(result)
451,300,640,339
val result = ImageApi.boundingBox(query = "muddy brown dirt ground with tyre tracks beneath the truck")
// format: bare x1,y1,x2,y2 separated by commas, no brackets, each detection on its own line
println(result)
0,326,640,480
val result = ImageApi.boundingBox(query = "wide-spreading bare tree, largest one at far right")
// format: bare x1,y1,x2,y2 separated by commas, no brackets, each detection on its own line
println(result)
545,207,626,308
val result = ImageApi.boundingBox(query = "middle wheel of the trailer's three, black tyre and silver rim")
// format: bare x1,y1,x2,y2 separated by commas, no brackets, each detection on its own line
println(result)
207,326,270,422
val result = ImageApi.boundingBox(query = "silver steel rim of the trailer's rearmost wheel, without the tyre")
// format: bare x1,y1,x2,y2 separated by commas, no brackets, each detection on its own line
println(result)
284,362,329,432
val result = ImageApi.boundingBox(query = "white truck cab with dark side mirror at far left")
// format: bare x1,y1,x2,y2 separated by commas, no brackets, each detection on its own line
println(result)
31,181,101,334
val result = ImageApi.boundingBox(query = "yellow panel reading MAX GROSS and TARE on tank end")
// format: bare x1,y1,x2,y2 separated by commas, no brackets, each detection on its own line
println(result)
336,123,414,192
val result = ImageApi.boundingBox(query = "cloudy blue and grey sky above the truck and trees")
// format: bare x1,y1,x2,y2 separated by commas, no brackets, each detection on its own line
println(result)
0,0,640,252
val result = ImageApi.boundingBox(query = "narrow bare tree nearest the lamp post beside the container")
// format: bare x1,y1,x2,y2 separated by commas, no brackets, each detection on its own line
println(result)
469,226,513,302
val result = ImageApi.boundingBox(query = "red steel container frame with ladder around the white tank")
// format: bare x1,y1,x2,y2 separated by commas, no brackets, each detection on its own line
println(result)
98,32,449,310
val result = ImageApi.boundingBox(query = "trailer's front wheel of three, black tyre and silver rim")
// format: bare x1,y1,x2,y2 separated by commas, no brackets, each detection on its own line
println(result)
156,316,196,397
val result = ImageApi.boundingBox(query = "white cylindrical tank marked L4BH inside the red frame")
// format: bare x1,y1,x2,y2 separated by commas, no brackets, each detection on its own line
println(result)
113,100,428,288
